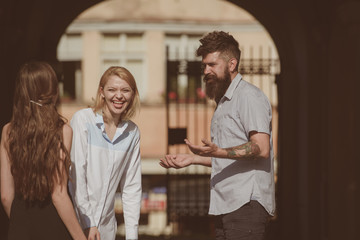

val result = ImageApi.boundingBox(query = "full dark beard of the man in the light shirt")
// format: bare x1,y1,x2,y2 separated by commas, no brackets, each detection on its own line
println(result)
204,70,231,103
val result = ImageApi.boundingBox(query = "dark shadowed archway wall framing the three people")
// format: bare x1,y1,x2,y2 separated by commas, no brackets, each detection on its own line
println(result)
0,0,360,240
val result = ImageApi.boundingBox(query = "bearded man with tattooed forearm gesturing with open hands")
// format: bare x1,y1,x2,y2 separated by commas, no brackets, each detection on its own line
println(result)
160,31,275,240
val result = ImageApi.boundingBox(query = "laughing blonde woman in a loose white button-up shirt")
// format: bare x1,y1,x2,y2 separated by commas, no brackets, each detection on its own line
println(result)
69,67,141,240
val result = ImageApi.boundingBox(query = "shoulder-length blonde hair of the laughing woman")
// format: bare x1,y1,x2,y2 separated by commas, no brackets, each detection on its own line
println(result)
92,66,140,121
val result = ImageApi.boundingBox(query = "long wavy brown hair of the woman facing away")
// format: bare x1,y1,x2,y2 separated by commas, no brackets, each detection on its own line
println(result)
8,62,70,201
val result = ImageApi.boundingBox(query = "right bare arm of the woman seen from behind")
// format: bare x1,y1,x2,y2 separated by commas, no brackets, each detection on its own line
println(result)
51,125,86,240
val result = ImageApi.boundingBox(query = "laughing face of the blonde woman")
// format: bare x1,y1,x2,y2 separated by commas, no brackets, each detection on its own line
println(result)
101,75,134,120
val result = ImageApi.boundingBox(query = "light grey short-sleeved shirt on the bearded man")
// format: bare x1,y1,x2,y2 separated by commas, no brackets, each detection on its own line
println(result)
209,74,275,215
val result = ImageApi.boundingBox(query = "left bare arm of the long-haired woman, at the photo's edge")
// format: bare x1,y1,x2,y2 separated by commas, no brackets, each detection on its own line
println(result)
0,123,15,218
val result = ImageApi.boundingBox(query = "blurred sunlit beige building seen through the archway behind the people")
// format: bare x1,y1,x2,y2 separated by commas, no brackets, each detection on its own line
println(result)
58,0,280,239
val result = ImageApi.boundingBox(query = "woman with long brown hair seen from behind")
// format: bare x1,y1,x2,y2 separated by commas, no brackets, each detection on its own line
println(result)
0,62,86,240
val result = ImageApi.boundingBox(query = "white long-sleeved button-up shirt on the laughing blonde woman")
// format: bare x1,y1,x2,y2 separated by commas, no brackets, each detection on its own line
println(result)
69,108,141,240
